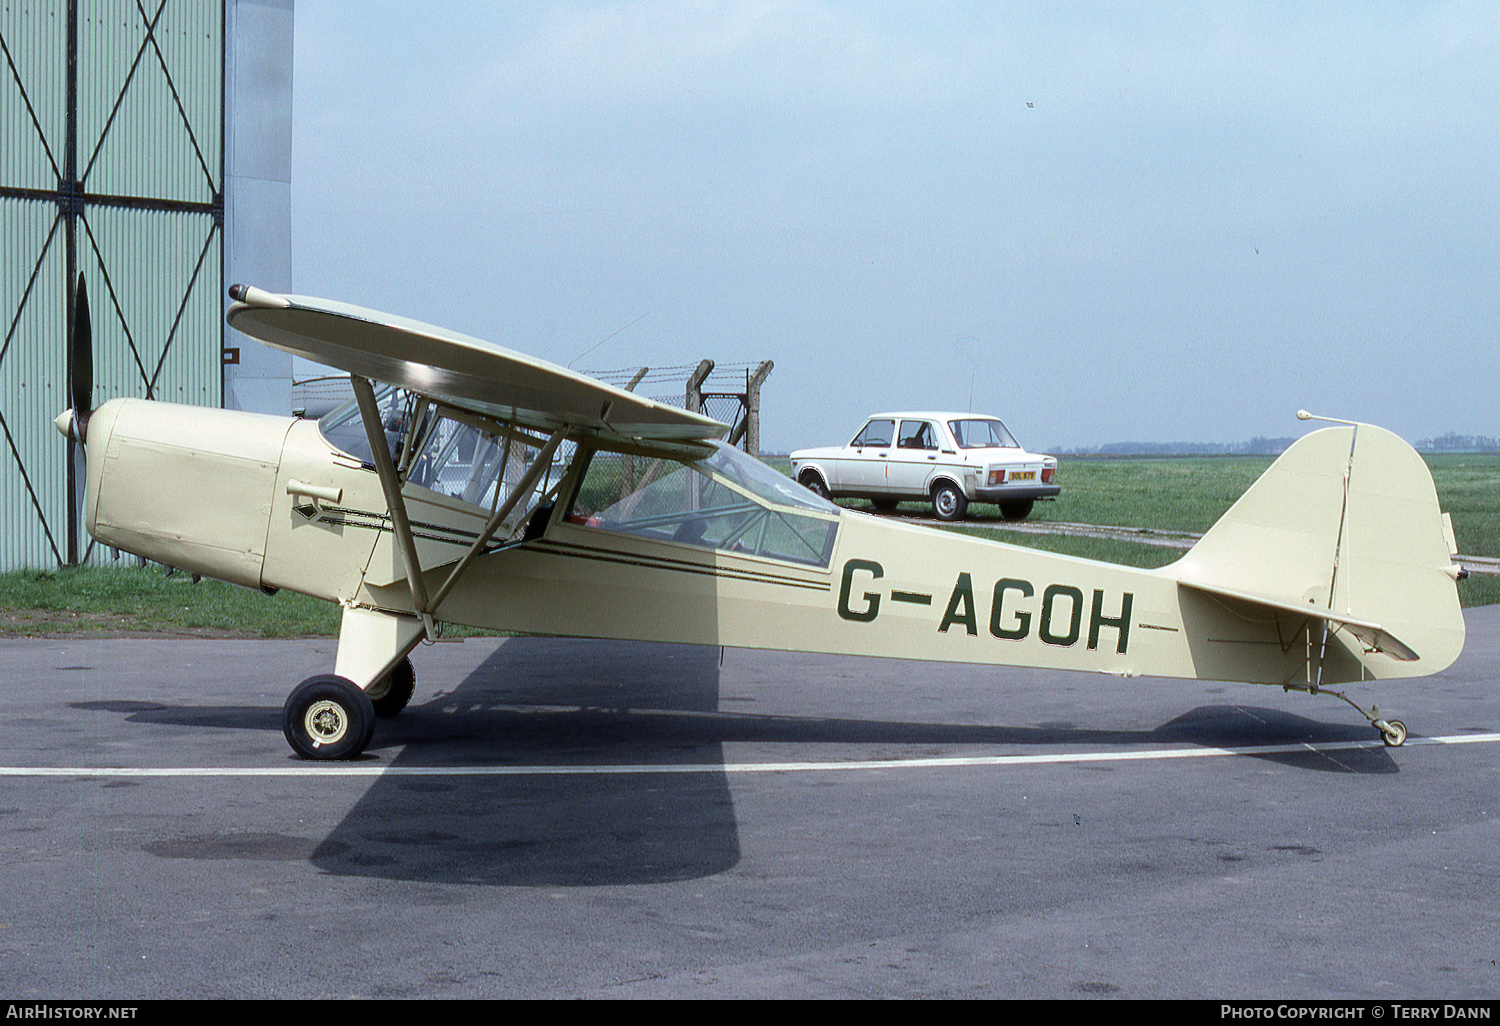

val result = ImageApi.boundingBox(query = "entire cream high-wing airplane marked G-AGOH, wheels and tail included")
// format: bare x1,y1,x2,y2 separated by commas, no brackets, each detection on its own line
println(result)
59,285,1464,759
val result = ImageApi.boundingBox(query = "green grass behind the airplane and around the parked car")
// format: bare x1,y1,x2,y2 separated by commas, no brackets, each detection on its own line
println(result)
0,453,1500,638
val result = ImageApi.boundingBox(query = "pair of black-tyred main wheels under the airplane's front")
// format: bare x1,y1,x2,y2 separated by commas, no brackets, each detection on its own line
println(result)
282,657,417,761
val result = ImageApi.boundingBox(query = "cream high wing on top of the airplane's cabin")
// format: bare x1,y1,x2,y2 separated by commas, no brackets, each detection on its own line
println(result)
225,285,729,443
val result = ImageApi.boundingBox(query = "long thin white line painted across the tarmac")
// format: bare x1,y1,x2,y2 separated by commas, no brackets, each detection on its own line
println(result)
0,734,1500,777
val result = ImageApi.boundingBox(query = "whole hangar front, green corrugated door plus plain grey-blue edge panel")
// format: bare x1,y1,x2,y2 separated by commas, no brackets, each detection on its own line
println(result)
0,0,293,570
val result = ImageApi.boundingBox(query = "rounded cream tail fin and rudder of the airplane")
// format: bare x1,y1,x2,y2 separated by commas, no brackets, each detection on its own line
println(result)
1166,425,1464,683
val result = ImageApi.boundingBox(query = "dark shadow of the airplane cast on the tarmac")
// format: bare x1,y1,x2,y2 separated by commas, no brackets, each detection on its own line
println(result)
70,638,1397,887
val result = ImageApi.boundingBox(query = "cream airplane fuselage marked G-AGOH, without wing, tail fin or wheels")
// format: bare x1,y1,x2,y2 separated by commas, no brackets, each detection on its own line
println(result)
87,401,1452,696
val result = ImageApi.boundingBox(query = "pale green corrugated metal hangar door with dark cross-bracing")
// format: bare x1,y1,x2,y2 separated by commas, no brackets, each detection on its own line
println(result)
0,0,237,569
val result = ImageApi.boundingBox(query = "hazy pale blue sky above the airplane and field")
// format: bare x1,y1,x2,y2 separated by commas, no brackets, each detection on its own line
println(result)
293,0,1500,452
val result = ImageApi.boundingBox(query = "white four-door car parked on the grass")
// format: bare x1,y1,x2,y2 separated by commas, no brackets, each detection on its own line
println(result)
792,413,1062,521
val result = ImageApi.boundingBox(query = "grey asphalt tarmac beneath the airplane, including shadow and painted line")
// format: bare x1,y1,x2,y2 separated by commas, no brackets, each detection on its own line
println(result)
0,606,1500,1002
